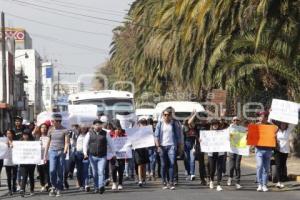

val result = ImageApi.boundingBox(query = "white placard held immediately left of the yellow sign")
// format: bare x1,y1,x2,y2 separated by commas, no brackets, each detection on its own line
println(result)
200,130,230,153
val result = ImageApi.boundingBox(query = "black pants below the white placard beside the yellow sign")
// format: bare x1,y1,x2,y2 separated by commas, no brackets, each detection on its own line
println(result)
208,153,224,185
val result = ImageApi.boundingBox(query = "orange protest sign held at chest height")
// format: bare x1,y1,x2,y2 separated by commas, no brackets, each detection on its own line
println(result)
247,124,278,147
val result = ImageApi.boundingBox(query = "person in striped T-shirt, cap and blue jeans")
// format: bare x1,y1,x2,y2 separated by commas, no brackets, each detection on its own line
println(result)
44,114,70,197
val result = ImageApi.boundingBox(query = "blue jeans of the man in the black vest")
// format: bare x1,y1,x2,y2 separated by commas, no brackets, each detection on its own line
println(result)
89,156,106,189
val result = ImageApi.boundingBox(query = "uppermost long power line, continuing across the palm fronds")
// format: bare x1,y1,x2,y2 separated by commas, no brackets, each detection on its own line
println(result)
12,0,171,31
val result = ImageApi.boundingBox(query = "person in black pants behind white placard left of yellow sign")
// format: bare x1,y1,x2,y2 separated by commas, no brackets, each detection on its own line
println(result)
200,119,225,191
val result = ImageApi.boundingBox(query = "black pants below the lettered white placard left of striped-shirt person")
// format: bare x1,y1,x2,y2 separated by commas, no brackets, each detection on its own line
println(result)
20,165,35,192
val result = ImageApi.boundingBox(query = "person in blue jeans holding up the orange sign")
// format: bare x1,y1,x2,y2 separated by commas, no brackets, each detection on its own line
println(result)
255,111,273,192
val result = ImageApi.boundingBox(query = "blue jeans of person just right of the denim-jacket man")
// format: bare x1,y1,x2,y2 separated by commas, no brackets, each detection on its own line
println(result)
184,141,196,175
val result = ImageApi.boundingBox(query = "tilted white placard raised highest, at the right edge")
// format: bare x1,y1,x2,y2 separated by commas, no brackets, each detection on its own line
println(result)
269,99,300,124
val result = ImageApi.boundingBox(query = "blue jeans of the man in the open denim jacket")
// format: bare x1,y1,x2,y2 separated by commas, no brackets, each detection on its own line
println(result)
159,145,176,184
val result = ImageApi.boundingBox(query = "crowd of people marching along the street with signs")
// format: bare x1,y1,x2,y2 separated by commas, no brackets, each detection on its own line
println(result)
0,107,293,197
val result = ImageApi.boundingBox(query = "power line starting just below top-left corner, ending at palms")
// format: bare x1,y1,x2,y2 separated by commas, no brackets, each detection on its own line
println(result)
5,12,112,37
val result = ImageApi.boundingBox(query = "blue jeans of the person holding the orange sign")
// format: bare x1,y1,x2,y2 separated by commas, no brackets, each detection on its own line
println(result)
255,148,273,185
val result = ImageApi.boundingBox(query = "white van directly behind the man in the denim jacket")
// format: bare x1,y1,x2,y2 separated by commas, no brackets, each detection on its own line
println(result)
155,101,207,122
